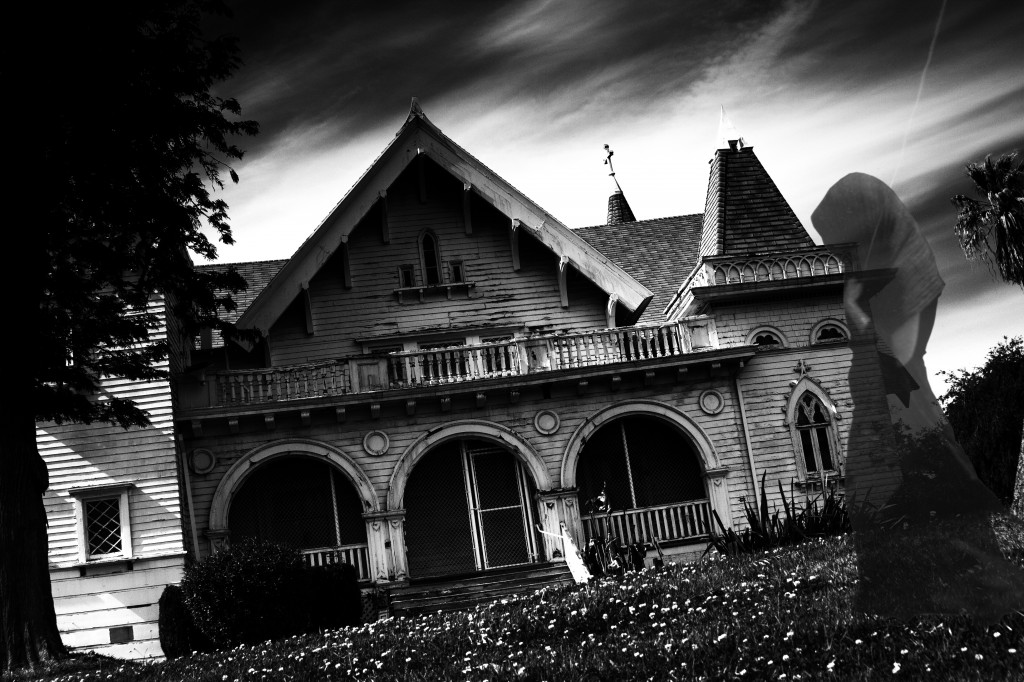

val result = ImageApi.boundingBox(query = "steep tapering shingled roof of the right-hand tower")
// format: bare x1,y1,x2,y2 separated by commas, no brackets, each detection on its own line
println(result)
700,140,814,256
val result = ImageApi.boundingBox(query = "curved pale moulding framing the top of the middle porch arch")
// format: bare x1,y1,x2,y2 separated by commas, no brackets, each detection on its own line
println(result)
387,419,552,509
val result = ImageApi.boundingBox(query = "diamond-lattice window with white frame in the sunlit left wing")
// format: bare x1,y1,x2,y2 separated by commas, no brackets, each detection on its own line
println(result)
70,485,132,563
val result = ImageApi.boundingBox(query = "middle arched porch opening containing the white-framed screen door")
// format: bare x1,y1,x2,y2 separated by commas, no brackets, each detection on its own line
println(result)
403,438,538,579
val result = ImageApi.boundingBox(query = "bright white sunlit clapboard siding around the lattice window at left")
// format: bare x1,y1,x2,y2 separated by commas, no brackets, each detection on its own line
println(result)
36,300,184,657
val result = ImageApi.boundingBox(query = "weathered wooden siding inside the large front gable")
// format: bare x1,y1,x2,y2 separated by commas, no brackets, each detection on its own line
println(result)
269,161,607,366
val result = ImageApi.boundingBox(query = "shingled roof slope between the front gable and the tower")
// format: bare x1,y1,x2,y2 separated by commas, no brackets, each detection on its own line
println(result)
575,213,702,324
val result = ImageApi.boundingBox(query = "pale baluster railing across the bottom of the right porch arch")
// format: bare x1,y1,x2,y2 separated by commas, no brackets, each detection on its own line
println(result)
581,500,711,545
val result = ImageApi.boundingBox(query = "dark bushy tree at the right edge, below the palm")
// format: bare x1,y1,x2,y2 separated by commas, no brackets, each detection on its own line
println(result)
939,336,1024,507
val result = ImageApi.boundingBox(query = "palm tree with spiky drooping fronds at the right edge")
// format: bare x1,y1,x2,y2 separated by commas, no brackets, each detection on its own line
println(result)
951,152,1024,287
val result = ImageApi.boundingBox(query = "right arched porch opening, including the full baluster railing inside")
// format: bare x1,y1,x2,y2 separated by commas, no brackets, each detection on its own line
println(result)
575,415,710,544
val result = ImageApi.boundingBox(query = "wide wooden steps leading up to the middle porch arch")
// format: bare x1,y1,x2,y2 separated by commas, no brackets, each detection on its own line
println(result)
390,563,572,615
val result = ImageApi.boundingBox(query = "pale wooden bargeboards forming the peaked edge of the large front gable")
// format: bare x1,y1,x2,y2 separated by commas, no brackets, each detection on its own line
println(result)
238,99,652,332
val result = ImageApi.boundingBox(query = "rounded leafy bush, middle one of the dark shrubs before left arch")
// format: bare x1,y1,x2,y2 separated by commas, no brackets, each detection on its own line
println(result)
181,540,306,647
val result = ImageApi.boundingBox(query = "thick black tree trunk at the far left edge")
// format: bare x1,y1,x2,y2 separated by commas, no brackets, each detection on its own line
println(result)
0,387,67,670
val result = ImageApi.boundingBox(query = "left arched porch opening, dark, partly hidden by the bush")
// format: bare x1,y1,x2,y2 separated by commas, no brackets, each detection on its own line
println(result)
227,455,370,580
